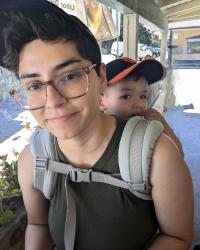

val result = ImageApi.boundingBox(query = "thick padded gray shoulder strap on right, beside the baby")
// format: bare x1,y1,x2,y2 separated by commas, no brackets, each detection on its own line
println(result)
118,116,163,200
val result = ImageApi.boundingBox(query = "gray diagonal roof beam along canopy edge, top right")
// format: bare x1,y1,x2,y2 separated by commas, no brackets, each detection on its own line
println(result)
98,0,168,32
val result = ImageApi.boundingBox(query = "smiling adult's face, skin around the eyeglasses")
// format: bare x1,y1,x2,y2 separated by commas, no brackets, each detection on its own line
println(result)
19,39,106,139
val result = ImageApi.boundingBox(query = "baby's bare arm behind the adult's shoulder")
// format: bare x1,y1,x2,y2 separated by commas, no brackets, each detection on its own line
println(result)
144,108,184,156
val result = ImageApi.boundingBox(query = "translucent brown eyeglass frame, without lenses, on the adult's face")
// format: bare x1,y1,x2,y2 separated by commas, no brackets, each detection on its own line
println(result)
9,63,99,110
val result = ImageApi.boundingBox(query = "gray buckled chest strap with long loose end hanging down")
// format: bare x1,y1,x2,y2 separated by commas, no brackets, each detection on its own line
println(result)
36,157,147,250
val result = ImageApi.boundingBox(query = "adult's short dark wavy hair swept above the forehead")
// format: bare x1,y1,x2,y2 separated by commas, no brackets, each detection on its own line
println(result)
2,2,101,75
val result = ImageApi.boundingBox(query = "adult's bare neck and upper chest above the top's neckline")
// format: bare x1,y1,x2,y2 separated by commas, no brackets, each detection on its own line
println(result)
58,114,116,168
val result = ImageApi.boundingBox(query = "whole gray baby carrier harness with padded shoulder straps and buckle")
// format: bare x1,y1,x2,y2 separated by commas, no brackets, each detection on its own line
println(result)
30,116,163,250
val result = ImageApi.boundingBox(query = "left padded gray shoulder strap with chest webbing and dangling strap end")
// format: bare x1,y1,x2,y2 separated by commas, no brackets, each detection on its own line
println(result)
30,130,76,250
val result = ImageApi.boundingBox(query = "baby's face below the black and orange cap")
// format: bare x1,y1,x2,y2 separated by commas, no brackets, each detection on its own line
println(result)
102,78,148,120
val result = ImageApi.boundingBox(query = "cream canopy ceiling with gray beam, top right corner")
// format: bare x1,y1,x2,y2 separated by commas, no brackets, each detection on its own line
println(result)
99,0,200,32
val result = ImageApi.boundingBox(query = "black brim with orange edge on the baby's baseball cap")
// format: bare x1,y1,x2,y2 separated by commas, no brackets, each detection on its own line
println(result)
108,59,165,85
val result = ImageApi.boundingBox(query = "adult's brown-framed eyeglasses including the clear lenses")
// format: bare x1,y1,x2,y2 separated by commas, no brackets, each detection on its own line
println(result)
10,64,97,110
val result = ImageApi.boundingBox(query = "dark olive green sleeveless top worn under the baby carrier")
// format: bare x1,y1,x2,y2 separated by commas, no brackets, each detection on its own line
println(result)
49,120,158,250
